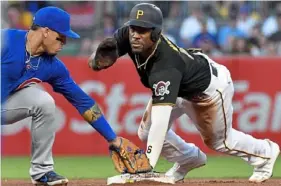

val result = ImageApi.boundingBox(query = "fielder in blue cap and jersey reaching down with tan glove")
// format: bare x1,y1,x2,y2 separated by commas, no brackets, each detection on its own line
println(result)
1,7,151,185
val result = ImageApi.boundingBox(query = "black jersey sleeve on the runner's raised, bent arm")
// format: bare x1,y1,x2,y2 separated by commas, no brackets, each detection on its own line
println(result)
114,26,130,57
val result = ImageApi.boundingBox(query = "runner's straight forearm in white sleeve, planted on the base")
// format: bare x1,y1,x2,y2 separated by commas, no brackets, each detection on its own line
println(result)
146,106,172,168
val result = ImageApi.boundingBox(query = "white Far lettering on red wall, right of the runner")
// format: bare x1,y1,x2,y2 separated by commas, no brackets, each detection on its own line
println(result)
233,80,281,132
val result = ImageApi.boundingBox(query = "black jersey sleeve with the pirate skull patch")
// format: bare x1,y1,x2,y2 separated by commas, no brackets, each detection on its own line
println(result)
149,68,182,106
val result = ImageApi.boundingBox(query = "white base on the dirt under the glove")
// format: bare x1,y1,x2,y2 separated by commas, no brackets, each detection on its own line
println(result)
107,172,175,185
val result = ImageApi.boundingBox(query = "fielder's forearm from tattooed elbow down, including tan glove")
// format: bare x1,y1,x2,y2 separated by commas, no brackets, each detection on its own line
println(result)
82,103,152,174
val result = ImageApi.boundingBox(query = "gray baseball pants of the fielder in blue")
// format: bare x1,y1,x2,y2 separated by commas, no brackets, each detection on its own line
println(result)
1,86,57,179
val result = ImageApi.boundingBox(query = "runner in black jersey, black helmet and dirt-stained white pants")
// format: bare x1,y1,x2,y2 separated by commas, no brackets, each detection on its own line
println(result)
89,3,279,182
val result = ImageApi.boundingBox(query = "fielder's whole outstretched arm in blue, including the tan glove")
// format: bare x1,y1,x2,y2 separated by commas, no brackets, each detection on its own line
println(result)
49,58,151,173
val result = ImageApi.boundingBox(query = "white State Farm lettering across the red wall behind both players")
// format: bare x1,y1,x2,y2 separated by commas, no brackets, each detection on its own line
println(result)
2,80,281,136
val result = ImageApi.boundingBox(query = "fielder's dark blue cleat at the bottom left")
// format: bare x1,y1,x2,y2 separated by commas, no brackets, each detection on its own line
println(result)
31,171,68,186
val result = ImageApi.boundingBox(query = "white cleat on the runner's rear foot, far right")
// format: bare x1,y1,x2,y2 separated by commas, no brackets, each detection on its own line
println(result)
249,140,280,183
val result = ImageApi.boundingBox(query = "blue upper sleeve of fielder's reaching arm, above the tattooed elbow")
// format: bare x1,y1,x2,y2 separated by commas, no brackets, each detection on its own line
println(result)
49,58,95,114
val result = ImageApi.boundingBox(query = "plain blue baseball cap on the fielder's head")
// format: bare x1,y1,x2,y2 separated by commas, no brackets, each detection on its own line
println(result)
33,6,80,38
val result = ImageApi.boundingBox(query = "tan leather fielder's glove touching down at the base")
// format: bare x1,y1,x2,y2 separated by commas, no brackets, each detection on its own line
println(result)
109,138,152,174
